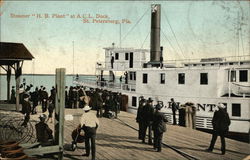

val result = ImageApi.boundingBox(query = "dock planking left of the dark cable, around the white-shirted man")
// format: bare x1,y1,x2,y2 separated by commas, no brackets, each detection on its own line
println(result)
62,110,183,160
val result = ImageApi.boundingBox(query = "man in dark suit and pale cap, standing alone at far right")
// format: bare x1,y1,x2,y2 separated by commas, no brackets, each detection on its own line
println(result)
206,103,231,154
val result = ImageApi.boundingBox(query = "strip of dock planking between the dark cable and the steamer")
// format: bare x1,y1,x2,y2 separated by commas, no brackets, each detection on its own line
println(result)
114,112,250,160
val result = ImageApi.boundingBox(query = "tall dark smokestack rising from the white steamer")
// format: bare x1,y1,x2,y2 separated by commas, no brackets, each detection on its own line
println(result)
149,4,161,66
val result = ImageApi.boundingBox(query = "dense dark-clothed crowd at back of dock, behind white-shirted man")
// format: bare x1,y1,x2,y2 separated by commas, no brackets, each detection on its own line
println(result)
10,84,122,126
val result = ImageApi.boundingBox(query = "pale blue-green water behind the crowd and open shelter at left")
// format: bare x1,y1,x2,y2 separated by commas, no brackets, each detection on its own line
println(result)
0,74,96,100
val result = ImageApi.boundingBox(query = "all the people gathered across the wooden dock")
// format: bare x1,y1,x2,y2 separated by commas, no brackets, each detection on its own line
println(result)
8,85,230,159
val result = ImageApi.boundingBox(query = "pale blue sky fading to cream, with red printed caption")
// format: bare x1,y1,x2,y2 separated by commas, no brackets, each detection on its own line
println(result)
0,0,250,74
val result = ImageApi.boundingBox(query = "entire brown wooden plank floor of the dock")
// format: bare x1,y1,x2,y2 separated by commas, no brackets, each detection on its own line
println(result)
0,106,250,160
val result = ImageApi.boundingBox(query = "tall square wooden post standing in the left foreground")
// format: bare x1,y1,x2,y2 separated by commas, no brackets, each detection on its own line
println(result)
54,68,65,160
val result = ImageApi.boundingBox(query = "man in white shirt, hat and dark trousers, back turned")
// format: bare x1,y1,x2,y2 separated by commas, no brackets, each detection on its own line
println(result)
80,105,99,160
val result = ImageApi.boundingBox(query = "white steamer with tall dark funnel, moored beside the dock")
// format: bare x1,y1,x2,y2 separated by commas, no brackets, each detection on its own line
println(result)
76,4,250,137
